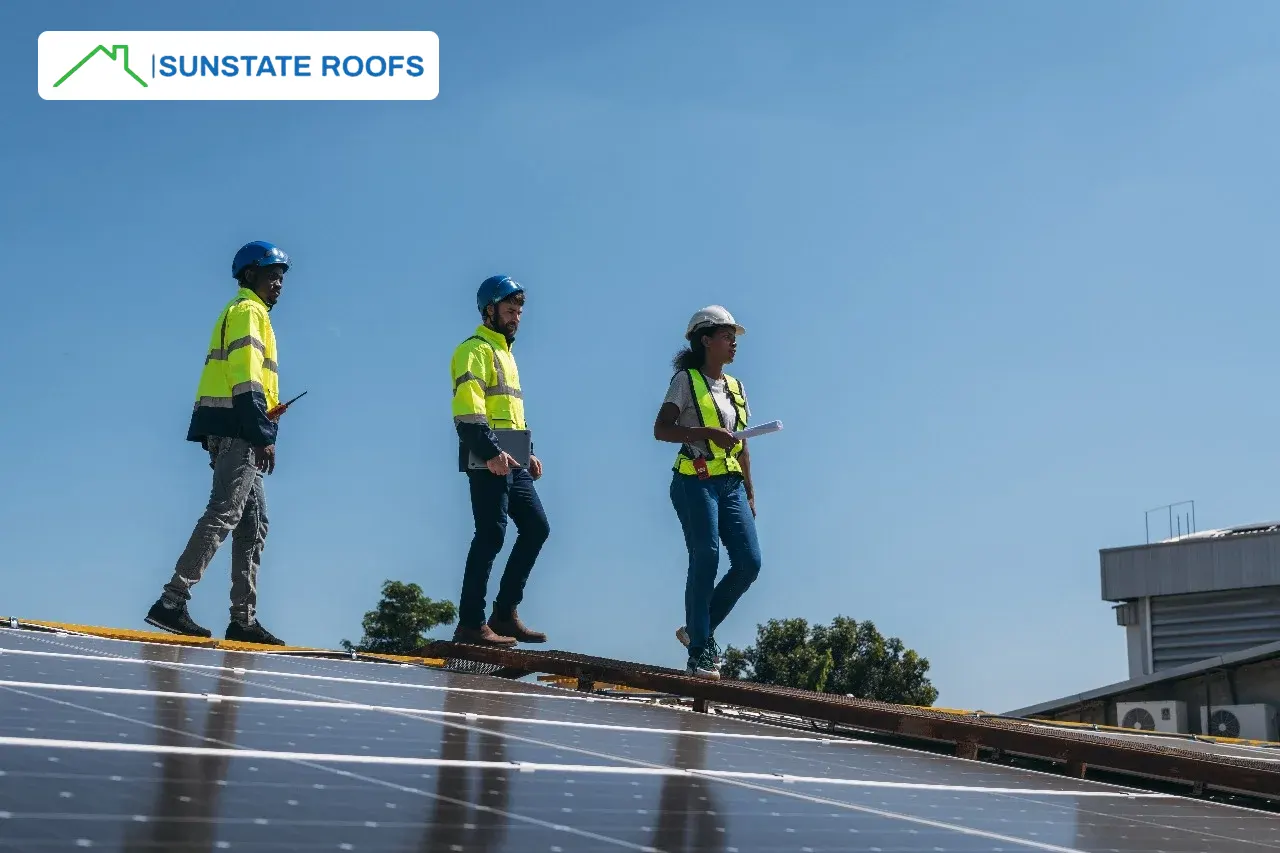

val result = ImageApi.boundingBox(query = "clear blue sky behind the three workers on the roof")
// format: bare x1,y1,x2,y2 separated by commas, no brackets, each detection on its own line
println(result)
0,0,1280,711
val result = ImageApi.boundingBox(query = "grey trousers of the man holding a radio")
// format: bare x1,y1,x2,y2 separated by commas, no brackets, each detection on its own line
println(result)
164,437,268,625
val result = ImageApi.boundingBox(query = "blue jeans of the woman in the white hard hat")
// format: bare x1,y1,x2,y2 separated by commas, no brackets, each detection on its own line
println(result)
671,473,760,654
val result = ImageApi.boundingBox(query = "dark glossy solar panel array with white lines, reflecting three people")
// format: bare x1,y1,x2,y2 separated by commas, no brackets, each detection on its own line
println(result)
0,629,1280,853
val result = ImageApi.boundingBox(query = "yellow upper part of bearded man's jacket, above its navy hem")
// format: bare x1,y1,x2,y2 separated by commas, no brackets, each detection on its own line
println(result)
451,325,527,429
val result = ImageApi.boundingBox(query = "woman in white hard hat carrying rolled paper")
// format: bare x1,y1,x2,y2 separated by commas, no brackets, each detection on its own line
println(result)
653,305,760,679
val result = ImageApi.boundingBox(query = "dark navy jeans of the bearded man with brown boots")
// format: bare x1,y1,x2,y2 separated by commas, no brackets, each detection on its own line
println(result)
458,469,550,628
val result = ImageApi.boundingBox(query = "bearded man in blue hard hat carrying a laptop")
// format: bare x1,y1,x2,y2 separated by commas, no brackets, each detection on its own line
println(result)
451,275,550,646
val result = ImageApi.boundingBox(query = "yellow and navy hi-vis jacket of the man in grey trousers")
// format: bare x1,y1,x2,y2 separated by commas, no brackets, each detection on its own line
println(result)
187,287,280,446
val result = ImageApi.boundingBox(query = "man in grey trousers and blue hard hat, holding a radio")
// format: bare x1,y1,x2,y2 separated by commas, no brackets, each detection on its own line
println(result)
146,241,291,646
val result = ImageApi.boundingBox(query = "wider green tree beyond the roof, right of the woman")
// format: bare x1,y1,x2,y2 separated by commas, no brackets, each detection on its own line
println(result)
723,616,938,706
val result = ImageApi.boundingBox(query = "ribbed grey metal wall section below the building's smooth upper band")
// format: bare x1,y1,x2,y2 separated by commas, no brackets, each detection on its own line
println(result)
1151,587,1280,672
